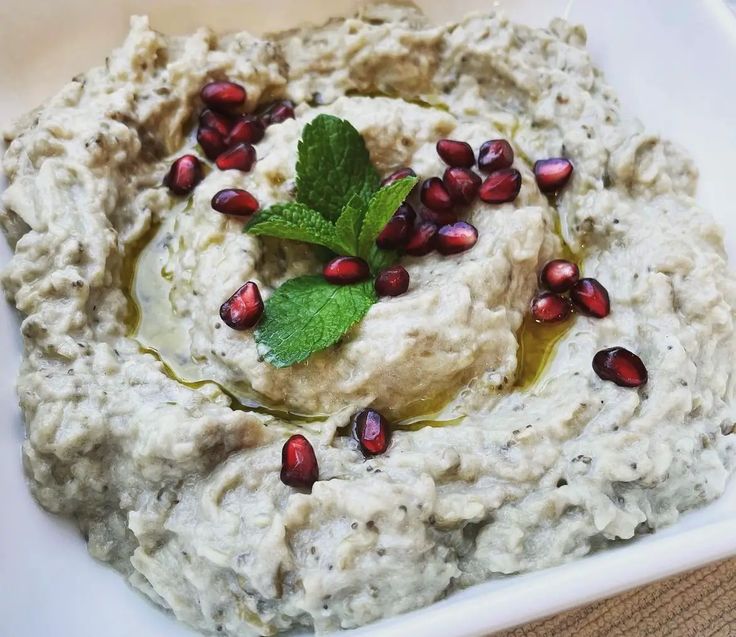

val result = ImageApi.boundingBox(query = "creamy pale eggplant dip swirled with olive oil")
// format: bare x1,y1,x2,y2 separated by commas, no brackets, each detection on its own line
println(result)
0,5,736,637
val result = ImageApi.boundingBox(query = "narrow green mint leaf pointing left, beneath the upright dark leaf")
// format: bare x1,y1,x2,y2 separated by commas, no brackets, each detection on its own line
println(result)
244,202,342,252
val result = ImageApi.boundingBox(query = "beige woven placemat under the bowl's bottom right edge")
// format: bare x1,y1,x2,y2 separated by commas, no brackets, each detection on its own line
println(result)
493,558,736,637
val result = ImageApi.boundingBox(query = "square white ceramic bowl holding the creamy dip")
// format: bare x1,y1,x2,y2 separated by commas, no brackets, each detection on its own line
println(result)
0,0,736,637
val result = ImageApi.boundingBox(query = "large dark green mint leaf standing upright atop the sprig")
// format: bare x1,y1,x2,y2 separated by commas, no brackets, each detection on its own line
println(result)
296,115,379,221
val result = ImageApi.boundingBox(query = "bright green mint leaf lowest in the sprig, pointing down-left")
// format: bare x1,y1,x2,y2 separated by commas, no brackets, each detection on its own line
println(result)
255,276,376,367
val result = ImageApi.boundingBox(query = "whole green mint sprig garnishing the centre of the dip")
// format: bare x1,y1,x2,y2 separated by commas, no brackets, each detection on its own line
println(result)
245,115,417,367
